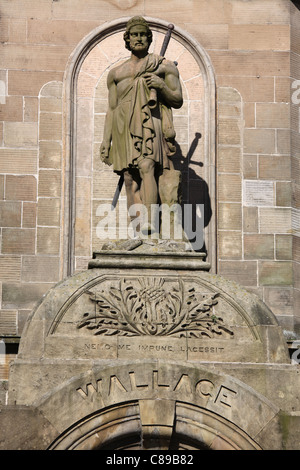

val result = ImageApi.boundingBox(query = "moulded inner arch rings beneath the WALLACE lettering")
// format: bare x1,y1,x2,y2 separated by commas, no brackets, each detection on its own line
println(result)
48,401,262,451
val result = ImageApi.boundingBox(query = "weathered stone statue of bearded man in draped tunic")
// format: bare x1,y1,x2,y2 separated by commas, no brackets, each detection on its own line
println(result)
100,17,183,237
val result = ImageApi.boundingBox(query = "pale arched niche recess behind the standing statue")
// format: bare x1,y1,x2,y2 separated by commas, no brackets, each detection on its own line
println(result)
63,17,216,276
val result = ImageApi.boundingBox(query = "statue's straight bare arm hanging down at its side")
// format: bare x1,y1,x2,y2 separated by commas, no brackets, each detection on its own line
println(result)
100,70,118,164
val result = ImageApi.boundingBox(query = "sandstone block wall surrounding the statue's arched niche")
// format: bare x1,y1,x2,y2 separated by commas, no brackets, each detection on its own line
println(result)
0,0,300,386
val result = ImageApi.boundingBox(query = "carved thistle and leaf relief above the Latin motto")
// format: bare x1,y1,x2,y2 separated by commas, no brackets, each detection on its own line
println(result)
77,277,233,338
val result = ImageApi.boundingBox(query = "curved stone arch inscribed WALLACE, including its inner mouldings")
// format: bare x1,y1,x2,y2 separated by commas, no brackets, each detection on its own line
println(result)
34,361,279,450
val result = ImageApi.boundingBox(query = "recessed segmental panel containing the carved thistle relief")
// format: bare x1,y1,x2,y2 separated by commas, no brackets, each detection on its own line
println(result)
48,274,258,341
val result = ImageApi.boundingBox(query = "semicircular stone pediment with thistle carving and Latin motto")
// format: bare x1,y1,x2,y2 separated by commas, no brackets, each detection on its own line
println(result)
10,258,289,414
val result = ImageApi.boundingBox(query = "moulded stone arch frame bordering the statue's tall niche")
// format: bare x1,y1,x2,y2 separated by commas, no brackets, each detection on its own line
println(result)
63,18,216,276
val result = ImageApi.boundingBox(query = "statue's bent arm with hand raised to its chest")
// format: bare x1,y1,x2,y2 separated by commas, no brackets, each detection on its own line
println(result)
144,61,183,109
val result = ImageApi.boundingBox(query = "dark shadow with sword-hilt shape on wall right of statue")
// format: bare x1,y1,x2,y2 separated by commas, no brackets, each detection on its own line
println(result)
172,132,212,254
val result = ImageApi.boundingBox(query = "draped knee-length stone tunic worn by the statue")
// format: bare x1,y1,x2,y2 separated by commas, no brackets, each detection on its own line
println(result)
109,54,175,173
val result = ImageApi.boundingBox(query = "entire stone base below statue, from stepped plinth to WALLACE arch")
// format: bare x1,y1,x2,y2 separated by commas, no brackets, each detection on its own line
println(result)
9,245,296,449
